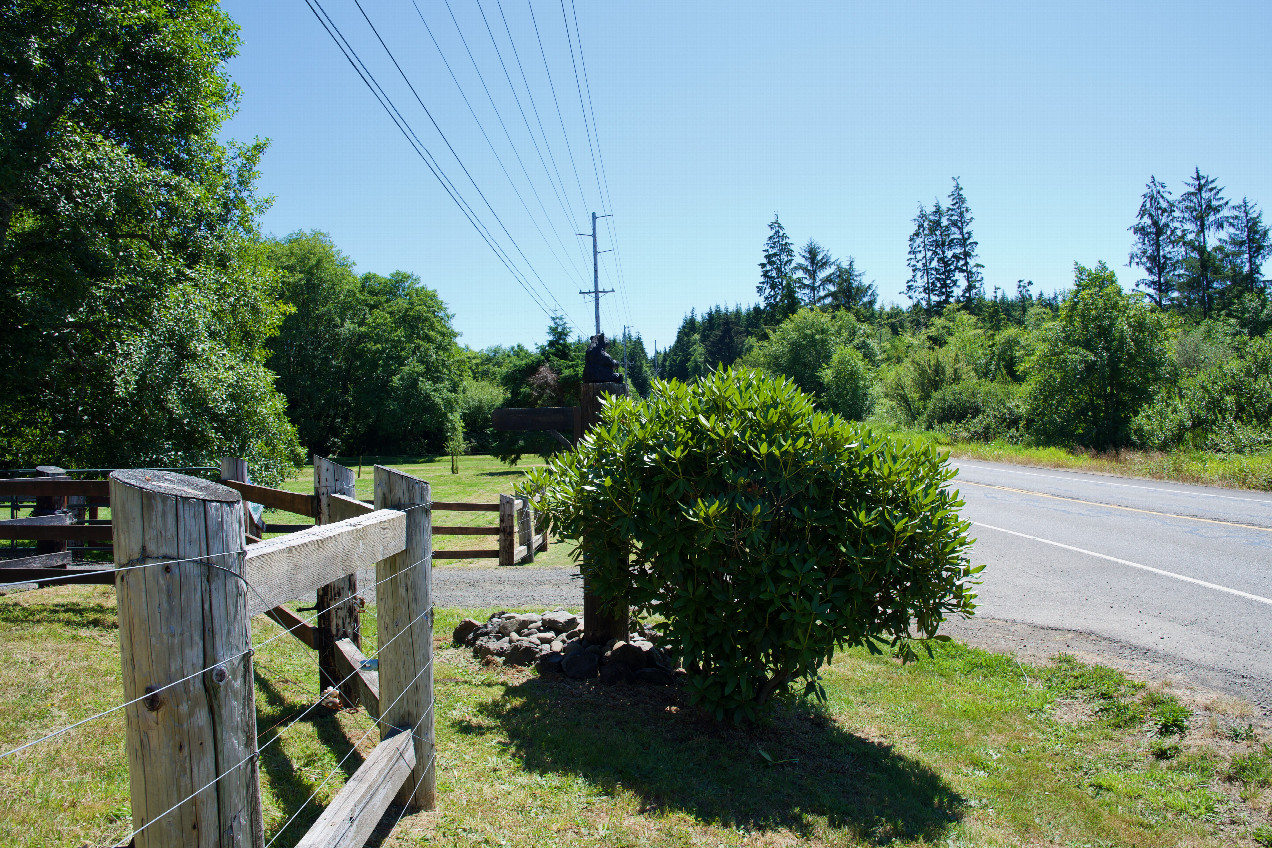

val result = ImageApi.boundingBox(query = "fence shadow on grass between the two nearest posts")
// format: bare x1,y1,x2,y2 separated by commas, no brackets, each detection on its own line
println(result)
256,674,363,848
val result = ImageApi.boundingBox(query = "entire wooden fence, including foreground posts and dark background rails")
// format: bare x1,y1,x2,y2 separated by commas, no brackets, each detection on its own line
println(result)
0,458,547,848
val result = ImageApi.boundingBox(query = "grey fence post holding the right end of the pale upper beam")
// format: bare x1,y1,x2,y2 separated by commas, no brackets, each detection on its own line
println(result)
375,465,438,810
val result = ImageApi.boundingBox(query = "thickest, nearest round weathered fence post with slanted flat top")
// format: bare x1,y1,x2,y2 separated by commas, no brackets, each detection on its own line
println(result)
111,470,265,848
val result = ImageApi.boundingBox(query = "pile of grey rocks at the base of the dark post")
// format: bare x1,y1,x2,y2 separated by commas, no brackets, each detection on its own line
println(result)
454,609,677,685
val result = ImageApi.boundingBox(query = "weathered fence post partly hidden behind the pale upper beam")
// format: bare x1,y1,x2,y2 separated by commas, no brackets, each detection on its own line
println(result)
314,456,363,706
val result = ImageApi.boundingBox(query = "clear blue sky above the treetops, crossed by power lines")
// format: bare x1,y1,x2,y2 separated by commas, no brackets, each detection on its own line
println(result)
223,0,1272,348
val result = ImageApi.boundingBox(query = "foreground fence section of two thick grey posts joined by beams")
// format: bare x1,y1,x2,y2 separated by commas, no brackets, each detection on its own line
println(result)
109,467,436,848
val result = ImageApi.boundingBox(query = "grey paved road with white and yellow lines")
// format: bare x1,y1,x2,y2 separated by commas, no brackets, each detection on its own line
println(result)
949,460,1272,715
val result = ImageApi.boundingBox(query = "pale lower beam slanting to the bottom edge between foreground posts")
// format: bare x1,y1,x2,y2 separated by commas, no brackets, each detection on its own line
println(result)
296,732,415,848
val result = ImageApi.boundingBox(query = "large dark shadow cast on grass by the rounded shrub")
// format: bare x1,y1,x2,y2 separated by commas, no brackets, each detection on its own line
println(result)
478,679,964,843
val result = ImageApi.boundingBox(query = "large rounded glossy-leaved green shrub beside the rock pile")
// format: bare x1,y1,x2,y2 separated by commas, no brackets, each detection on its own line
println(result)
527,369,981,721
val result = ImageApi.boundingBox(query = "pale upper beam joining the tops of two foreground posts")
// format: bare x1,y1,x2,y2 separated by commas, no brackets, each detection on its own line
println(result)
243,510,406,615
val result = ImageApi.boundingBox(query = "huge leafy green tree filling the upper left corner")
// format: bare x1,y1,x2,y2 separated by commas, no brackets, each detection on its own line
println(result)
0,0,298,478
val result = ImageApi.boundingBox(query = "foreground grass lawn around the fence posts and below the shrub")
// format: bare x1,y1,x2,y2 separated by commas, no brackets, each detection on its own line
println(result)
0,586,1272,848
